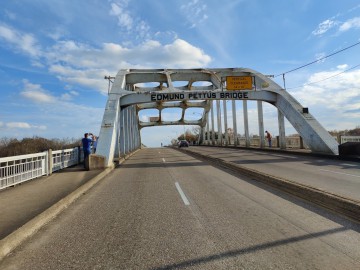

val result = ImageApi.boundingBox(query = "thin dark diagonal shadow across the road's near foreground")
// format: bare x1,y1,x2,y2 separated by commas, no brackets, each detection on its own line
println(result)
152,227,349,270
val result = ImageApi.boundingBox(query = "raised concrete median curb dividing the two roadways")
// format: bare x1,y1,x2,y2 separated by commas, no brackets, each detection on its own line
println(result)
178,149,360,223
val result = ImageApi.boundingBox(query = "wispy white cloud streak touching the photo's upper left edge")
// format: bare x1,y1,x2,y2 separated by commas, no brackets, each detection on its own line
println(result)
0,25,41,57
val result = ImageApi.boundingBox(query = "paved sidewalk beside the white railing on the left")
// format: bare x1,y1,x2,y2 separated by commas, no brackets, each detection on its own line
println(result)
0,165,102,240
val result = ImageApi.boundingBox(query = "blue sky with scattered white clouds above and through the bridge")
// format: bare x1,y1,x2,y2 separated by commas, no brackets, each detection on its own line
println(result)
0,0,360,146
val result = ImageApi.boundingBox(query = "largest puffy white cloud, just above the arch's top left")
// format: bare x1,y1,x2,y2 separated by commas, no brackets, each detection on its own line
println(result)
47,39,211,93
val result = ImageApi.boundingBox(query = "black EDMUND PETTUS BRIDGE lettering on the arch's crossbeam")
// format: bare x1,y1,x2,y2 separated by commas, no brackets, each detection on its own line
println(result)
151,91,249,101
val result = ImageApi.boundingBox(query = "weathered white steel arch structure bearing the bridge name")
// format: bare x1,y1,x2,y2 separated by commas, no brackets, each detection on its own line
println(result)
97,68,338,167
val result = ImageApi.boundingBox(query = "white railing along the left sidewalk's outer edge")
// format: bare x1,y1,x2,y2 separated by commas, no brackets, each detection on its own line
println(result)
0,147,84,189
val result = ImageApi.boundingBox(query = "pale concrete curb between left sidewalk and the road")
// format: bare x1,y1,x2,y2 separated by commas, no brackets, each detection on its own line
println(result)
0,168,113,261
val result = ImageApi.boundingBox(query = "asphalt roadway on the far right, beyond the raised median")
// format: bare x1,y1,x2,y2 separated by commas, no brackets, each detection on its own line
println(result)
186,147,360,201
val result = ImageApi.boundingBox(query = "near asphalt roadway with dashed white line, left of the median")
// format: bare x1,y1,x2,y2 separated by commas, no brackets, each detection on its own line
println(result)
0,148,360,270
